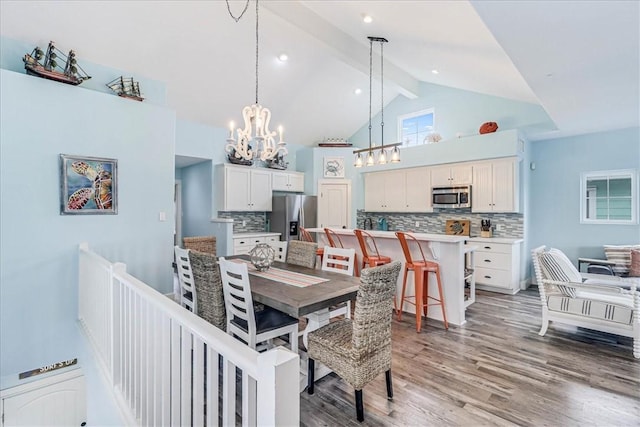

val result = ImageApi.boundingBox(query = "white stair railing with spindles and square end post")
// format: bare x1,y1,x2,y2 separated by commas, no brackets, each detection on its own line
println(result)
78,244,300,426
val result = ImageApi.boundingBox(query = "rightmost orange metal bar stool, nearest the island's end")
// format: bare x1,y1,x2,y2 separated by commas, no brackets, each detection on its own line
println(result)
396,231,449,332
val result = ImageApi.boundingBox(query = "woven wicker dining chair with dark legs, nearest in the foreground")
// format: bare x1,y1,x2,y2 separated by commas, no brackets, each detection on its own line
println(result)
307,261,401,421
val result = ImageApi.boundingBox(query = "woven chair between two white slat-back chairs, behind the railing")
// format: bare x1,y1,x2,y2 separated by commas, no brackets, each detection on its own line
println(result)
189,250,227,331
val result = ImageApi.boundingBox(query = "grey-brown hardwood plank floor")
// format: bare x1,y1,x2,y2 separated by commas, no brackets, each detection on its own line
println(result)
300,287,640,426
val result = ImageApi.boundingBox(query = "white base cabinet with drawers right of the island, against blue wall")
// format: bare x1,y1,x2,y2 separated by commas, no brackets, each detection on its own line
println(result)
467,238,522,294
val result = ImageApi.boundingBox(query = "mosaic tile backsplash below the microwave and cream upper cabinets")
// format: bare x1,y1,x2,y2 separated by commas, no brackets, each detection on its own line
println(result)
357,209,524,238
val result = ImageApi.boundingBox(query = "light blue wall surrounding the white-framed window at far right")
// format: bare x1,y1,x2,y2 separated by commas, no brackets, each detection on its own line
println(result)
528,128,640,261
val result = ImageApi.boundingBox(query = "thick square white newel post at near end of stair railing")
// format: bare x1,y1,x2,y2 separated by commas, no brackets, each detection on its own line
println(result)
257,347,300,426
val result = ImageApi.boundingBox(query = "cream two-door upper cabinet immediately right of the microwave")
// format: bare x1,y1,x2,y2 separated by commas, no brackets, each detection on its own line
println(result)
471,158,520,212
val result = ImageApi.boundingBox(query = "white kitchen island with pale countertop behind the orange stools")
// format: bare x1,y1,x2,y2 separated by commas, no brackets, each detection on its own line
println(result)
308,228,474,326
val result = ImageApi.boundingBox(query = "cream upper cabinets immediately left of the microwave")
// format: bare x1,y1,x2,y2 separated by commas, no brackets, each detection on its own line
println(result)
364,168,432,212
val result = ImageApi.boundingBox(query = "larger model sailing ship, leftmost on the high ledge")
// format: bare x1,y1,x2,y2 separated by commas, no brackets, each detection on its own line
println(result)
22,42,91,85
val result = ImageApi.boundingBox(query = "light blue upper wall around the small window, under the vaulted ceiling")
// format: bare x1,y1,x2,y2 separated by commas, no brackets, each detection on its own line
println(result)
349,83,555,147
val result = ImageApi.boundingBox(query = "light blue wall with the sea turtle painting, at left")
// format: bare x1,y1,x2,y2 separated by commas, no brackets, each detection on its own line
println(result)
0,70,175,390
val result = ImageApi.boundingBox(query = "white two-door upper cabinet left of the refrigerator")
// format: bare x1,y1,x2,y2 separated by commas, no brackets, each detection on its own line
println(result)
217,164,271,212
